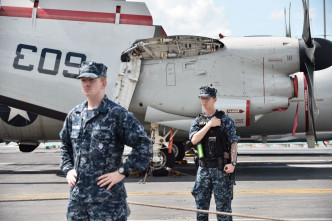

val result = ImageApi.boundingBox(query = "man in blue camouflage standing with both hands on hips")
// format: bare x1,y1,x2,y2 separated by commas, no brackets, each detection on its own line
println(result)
60,61,152,221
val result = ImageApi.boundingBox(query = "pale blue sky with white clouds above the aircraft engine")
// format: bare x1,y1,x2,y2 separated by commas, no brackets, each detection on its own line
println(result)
135,0,332,40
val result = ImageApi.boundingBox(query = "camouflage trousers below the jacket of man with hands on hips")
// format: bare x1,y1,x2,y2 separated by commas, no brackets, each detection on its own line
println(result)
67,200,129,221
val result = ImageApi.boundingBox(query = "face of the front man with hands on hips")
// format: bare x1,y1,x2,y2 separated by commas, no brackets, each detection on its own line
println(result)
81,77,107,98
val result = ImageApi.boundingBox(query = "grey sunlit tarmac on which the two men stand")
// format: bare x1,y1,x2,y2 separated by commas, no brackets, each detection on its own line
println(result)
0,147,332,221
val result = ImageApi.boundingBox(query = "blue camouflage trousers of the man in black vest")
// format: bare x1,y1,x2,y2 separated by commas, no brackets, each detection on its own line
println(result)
191,167,233,221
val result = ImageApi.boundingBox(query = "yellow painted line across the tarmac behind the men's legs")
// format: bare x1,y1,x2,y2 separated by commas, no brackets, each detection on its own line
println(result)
0,189,332,199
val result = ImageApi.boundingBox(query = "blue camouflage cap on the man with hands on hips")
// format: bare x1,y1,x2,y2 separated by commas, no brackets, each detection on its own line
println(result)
77,61,107,79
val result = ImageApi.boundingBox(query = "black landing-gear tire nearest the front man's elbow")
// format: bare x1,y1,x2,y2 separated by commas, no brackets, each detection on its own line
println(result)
152,149,175,176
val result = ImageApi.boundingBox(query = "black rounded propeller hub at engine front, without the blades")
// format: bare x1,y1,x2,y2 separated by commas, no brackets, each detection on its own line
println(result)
299,38,332,72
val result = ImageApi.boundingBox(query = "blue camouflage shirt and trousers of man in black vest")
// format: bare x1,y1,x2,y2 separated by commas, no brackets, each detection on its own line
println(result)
189,110,239,221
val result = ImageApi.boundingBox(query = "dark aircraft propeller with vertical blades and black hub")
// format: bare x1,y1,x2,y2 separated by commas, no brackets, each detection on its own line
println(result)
299,0,332,142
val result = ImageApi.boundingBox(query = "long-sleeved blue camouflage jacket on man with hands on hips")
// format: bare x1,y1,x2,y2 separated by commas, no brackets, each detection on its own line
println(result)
60,96,152,203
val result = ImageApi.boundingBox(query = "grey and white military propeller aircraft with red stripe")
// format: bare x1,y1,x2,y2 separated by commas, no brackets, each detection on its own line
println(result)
0,0,332,174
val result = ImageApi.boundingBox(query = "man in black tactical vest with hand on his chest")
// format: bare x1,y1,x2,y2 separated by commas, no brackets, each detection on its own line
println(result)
189,86,238,221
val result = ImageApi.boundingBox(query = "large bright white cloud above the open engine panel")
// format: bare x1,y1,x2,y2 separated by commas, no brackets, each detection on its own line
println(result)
132,0,231,38
